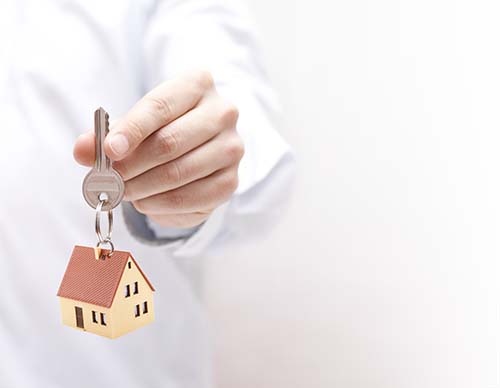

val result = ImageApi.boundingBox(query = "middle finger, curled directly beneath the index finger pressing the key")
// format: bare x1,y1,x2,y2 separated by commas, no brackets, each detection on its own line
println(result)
114,99,238,180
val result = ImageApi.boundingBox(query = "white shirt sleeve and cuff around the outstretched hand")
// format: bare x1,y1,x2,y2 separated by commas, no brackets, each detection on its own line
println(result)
125,0,293,256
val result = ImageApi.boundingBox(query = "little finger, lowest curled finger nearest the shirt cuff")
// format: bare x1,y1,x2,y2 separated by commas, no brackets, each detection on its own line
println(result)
133,167,238,217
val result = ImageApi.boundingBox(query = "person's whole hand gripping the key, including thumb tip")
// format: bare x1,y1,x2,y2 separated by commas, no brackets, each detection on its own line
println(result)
74,71,244,228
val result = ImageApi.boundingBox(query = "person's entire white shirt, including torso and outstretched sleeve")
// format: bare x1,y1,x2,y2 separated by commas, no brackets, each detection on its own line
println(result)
0,0,292,388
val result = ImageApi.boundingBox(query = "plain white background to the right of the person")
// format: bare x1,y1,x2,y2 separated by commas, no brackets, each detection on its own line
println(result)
204,0,500,388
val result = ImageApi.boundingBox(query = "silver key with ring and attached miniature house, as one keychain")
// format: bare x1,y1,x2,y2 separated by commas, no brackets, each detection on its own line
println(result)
57,108,154,338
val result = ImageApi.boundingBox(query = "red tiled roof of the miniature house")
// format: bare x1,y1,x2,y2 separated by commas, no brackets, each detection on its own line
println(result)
57,245,154,308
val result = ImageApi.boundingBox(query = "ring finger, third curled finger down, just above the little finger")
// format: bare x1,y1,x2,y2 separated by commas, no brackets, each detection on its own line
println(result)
124,130,244,201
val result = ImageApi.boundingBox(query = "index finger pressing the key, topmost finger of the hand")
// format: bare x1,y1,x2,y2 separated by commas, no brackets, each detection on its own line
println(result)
104,71,213,160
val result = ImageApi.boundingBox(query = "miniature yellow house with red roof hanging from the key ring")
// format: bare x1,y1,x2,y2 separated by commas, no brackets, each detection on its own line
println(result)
57,246,154,338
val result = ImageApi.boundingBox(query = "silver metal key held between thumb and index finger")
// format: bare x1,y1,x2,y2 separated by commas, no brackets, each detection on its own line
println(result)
82,108,125,211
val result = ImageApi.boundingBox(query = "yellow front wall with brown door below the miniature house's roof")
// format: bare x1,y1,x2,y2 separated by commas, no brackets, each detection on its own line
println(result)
59,297,113,337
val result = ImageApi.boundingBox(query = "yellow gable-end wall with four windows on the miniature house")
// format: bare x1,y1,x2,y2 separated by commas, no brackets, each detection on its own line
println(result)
111,257,154,338
